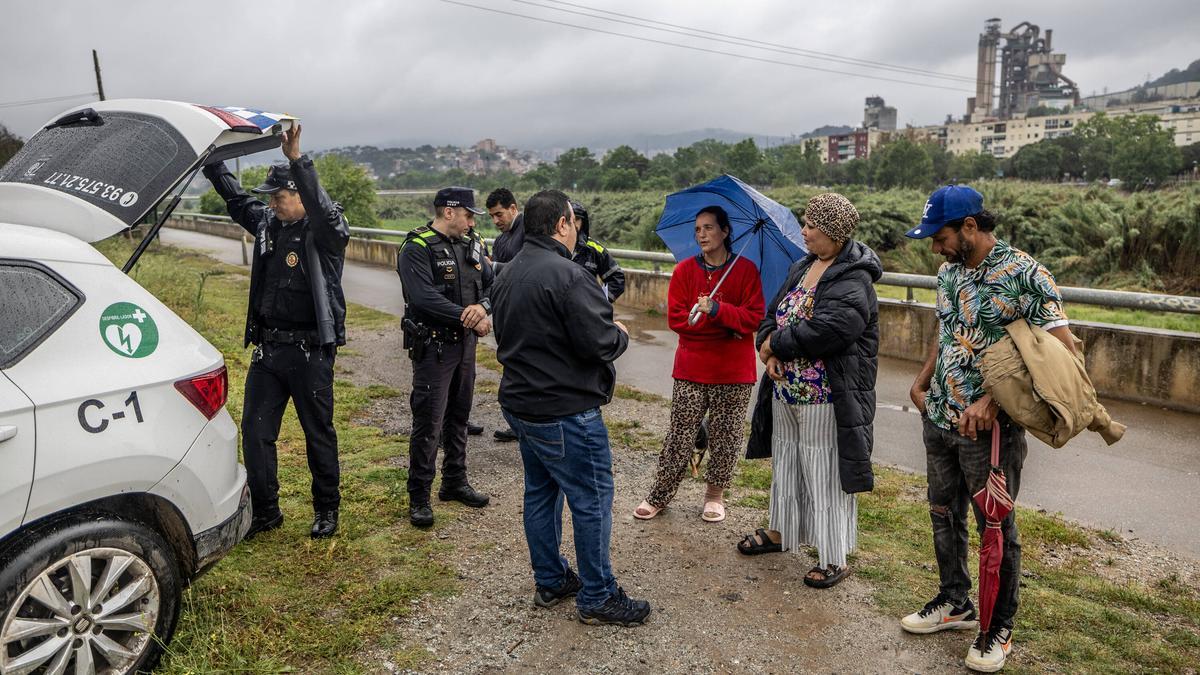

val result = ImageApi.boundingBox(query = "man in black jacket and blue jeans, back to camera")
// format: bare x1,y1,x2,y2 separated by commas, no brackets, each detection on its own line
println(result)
492,190,650,626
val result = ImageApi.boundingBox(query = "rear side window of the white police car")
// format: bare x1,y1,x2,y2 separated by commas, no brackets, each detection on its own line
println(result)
0,259,83,369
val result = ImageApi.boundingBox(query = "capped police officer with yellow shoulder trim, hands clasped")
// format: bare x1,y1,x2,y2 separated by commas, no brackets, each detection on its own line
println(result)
396,187,493,527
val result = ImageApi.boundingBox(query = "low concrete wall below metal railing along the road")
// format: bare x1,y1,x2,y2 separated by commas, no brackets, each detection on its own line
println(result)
167,217,1200,413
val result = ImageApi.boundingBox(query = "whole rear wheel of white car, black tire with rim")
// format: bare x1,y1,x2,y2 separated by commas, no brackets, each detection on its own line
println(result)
0,514,182,673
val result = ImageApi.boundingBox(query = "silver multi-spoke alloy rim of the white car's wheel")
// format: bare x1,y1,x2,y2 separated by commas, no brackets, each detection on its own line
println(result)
0,548,161,675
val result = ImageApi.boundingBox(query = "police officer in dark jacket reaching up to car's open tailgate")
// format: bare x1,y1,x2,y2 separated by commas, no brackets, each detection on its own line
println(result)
204,125,350,538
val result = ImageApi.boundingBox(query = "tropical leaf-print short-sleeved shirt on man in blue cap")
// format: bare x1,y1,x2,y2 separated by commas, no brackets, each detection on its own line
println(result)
925,239,1067,430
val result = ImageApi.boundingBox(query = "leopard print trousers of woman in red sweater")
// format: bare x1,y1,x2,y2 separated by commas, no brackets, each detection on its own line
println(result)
646,380,754,508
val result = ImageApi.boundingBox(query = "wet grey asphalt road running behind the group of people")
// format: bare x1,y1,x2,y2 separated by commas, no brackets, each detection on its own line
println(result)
162,229,1200,557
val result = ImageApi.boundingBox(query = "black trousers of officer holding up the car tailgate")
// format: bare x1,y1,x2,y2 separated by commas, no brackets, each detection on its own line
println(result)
241,341,341,518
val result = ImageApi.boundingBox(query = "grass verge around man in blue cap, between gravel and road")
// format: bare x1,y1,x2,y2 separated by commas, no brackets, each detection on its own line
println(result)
734,460,1200,673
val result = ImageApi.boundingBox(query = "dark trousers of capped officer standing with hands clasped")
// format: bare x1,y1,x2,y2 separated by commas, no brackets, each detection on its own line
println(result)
408,330,478,506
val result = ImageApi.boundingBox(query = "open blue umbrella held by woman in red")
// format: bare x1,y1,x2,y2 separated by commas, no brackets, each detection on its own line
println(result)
654,174,808,323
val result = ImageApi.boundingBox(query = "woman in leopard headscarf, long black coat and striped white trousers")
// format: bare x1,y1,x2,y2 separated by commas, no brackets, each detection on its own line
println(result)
738,192,883,589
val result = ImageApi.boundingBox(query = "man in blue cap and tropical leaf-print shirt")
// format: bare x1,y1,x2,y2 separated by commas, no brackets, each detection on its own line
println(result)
900,185,1074,673
